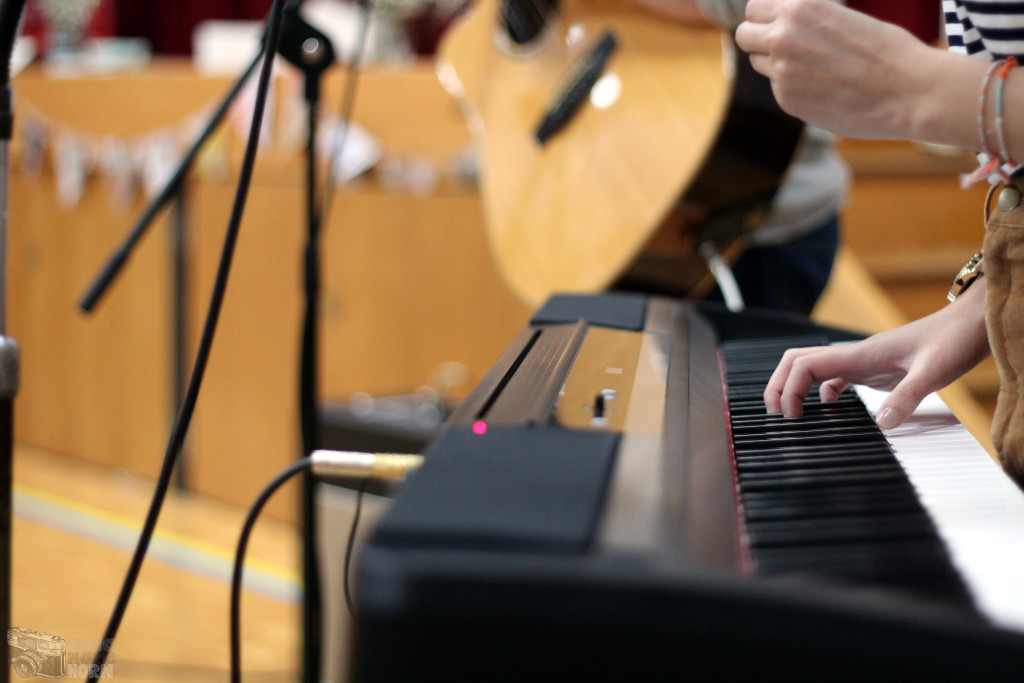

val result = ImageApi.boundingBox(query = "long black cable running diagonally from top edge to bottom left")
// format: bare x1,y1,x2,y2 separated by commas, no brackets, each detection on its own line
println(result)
89,0,285,680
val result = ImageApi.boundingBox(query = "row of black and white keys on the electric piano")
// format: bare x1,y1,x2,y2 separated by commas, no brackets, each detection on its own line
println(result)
722,339,1024,629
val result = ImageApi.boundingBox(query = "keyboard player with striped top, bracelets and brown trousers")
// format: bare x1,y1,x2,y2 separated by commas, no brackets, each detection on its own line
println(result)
736,0,1024,482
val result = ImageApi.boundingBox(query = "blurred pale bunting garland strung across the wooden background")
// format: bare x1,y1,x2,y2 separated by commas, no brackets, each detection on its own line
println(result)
15,66,476,211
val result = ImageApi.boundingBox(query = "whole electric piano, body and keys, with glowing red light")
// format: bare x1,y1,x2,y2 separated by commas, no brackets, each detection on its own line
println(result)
350,295,1024,681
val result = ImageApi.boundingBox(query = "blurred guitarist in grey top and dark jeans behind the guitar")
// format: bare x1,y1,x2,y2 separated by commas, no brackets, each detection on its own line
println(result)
635,0,850,315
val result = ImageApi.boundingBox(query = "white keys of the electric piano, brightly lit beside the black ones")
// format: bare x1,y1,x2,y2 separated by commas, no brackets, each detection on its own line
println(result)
856,387,1024,631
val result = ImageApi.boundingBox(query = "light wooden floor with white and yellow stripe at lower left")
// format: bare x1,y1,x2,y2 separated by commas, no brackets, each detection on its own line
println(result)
11,445,301,681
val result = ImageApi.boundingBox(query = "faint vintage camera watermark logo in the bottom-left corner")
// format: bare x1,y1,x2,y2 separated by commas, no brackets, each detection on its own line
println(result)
7,627,114,679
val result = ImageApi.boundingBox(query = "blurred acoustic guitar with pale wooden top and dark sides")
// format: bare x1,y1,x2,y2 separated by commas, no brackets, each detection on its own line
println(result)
437,0,802,305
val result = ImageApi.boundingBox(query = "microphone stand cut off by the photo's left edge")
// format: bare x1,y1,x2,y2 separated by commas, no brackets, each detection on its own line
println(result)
0,0,26,683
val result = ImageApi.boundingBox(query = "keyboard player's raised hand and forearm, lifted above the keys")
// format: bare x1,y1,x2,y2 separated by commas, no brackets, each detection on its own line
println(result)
736,0,1024,159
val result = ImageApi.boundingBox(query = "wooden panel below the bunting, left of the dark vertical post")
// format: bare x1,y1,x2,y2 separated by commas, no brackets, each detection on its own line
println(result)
7,174,173,475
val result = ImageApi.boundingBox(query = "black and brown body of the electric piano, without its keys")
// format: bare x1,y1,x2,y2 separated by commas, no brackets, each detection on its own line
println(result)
351,294,1024,681
